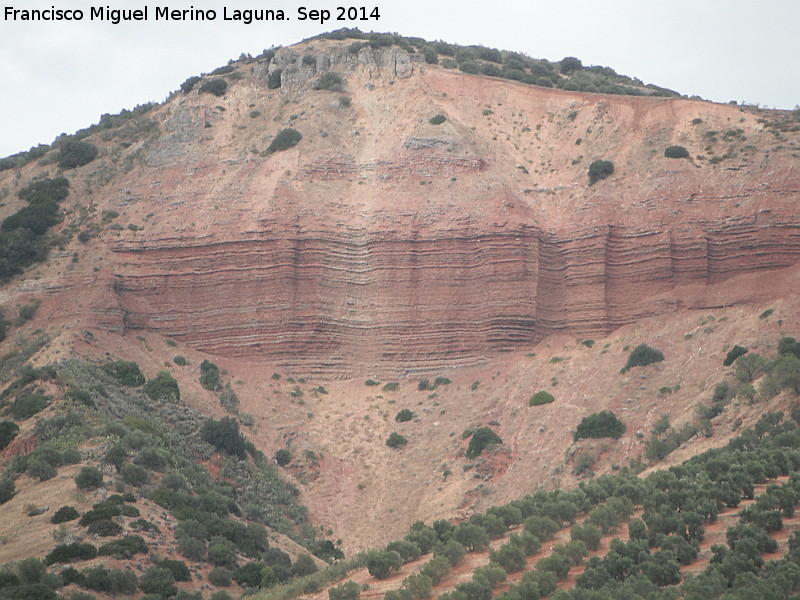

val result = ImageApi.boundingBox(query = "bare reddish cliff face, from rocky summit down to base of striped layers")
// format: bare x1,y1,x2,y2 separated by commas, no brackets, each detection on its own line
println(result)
7,42,800,376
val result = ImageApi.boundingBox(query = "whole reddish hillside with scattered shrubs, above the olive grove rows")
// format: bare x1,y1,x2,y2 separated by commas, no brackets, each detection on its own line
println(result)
0,32,800,600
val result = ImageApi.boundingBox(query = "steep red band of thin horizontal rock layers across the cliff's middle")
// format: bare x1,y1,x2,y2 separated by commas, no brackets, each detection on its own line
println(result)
109,216,800,375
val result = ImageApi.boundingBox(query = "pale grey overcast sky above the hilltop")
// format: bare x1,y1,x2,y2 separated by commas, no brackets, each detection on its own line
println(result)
0,0,800,157
